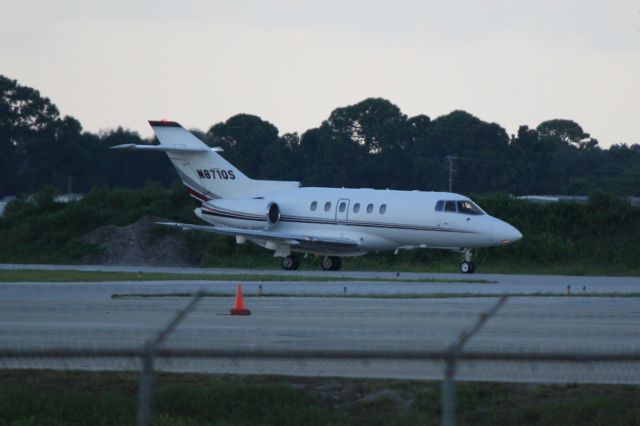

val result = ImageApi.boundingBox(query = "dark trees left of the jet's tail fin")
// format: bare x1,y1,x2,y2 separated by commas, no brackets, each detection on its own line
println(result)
0,76,175,195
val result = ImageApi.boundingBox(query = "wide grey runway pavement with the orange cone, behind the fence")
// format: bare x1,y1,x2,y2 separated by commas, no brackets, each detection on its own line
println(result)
0,262,640,384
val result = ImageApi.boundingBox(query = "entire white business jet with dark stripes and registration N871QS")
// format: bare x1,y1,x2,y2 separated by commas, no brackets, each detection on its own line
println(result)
114,120,522,273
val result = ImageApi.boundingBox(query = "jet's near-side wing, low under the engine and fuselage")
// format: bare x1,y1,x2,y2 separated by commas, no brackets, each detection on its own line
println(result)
156,222,359,250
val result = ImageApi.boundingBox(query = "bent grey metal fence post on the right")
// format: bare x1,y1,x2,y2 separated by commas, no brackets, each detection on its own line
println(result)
441,295,508,426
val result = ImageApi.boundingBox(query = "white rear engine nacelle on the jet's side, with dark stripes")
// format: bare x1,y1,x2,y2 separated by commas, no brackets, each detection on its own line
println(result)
201,198,280,226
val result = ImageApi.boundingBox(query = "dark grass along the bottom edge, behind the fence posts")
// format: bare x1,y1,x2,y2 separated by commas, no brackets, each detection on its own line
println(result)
0,370,640,426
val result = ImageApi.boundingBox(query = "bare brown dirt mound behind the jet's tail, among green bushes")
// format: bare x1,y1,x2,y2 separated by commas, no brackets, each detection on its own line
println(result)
80,216,196,266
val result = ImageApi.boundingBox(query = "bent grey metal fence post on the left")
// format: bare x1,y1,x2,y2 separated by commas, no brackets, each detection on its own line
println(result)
138,290,204,426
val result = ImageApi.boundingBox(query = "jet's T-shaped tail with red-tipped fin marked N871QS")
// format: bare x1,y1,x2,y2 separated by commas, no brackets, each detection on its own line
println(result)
113,120,300,202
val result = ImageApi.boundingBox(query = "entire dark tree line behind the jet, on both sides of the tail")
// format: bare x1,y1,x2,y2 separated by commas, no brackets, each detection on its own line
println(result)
0,75,640,196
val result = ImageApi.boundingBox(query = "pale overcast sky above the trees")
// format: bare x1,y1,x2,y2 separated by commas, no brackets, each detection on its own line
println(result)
0,0,640,147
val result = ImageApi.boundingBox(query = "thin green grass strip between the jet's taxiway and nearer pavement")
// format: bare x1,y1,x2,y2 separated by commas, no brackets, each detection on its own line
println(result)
0,269,495,284
